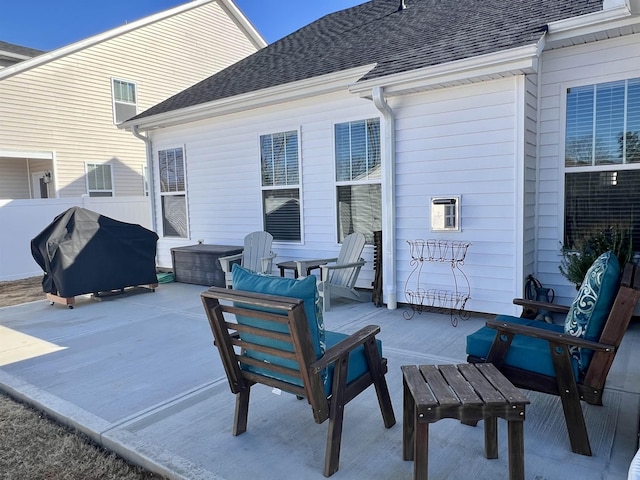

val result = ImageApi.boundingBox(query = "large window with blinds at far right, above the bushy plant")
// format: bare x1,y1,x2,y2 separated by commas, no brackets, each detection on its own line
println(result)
564,79,640,251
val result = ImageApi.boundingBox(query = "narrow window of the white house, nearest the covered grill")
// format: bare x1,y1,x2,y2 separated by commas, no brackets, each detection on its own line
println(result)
158,148,188,238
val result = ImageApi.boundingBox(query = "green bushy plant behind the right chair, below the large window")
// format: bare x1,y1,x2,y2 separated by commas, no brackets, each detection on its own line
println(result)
559,226,633,289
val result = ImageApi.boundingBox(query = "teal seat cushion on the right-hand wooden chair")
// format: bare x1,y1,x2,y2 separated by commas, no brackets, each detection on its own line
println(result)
467,315,578,379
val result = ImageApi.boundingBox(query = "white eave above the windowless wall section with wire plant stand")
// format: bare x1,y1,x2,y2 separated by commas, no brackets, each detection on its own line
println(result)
349,43,544,97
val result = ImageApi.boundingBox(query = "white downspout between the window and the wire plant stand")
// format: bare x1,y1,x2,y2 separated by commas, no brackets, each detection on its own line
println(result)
372,87,398,310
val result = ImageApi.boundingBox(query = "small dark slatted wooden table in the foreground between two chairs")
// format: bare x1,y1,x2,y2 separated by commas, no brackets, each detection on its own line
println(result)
400,363,529,480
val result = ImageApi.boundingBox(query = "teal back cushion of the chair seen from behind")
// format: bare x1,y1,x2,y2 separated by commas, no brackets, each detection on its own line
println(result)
232,265,326,386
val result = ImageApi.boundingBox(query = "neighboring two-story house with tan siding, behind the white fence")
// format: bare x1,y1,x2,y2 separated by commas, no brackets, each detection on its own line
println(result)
0,0,266,199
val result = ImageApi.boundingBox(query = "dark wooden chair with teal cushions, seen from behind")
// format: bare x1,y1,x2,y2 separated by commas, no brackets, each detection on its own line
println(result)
202,265,396,477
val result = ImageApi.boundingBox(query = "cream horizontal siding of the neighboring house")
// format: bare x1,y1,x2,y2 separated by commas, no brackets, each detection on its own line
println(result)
0,2,256,197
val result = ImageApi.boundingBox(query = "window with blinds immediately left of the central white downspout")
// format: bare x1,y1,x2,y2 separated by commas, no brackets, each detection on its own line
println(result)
335,118,382,244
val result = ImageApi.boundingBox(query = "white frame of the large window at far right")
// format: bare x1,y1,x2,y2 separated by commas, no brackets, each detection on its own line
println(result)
557,74,640,251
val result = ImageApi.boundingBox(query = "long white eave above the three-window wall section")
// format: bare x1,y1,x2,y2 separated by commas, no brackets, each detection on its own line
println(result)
118,64,375,131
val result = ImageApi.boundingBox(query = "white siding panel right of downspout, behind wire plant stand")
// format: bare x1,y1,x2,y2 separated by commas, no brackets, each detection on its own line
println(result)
390,77,533,313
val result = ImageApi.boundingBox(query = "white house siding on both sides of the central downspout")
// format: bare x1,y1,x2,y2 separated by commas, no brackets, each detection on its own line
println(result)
148,79,524,312
